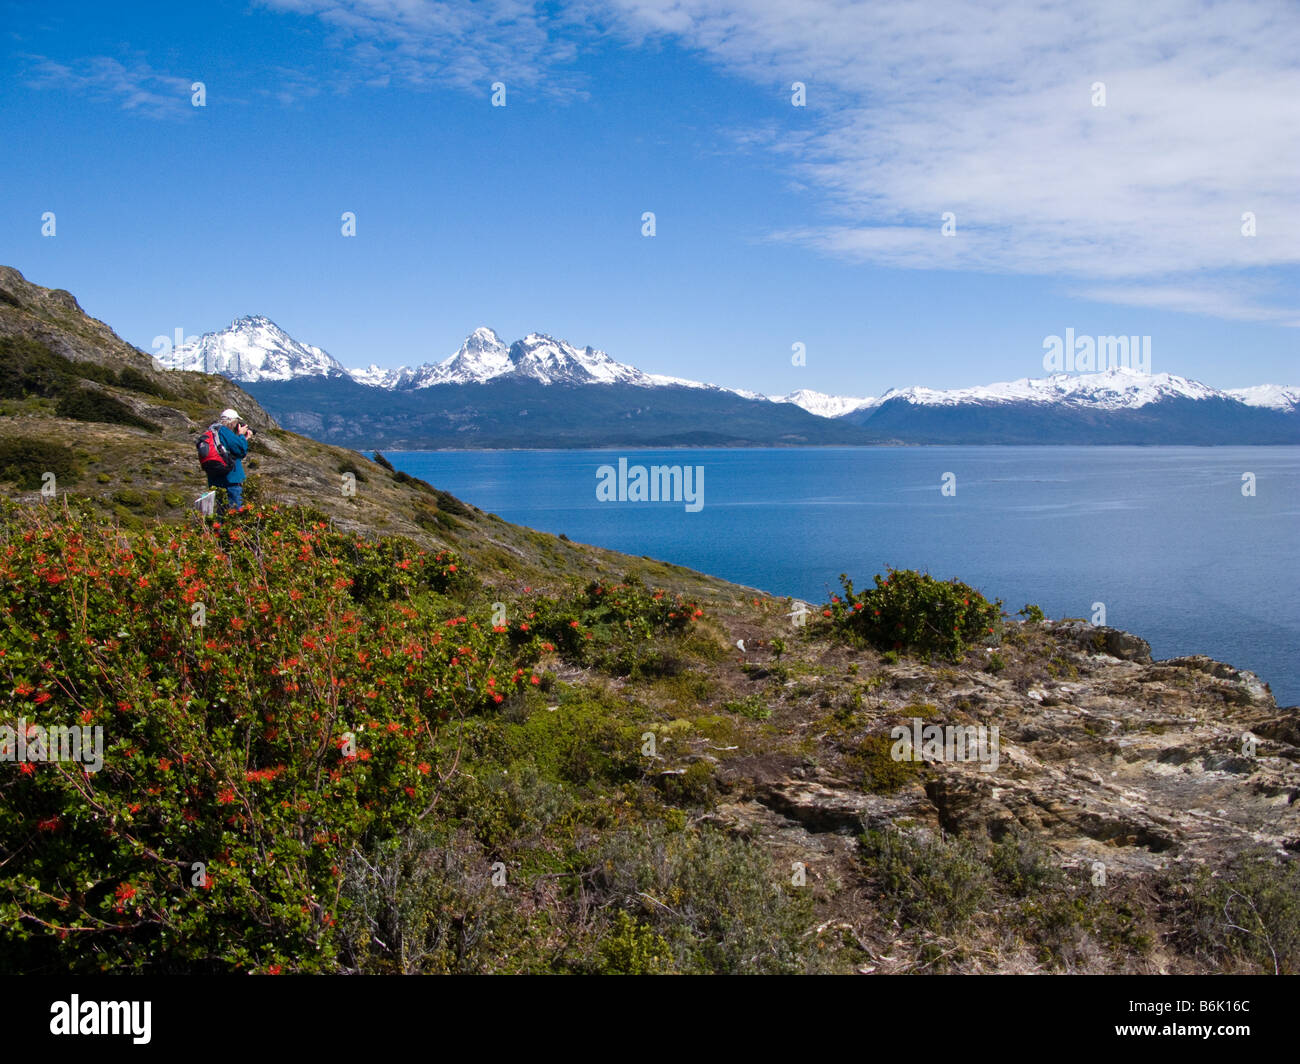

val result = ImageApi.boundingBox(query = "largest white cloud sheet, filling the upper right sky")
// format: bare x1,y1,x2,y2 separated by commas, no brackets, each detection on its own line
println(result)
585,0,1300,323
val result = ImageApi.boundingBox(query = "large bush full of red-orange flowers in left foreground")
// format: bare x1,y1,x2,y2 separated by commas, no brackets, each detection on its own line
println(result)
0,507,541,972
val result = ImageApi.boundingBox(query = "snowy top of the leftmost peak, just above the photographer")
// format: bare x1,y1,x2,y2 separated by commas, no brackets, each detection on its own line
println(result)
159,315,347,382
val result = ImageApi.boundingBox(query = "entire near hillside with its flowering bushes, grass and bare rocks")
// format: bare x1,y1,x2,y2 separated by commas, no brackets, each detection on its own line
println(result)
0,271,1300,973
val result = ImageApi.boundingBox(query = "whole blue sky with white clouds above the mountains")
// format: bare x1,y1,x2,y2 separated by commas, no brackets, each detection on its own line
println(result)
0,0,1300,395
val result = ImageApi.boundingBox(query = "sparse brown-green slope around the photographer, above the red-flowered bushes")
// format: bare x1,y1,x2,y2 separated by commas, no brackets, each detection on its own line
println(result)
0,267,723,592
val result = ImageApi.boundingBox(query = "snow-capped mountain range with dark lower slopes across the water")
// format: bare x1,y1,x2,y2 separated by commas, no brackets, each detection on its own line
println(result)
159,316,1300,449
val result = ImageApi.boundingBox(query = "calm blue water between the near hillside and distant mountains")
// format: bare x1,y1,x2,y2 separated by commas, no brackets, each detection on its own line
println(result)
389,447,1300,705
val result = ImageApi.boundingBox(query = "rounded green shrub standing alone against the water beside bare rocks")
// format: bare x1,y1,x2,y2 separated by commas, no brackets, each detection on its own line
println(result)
823,568,1002,661
